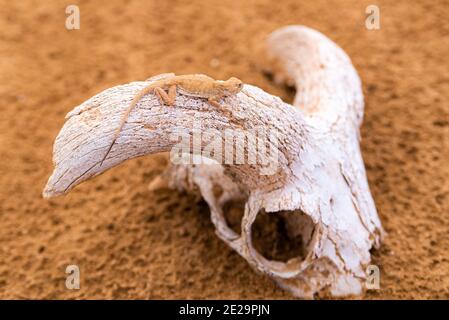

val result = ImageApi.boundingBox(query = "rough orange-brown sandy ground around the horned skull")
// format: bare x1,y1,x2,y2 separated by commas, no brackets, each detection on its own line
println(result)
0,0,449,299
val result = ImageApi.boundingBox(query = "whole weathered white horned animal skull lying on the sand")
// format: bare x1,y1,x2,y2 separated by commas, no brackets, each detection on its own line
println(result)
44,26,383,298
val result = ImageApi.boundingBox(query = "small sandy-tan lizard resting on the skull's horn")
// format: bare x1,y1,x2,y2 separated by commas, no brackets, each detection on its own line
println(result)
100,73,243,167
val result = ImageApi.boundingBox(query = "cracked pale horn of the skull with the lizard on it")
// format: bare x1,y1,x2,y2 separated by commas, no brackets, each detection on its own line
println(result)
44,78,306,197
